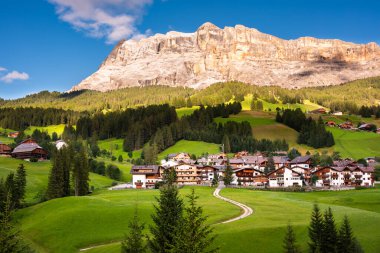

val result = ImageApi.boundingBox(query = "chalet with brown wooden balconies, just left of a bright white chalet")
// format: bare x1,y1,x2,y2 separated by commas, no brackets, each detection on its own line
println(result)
232,167,268,186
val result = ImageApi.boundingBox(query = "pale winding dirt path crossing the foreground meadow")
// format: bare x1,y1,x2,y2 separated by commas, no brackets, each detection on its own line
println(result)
79,184,253,252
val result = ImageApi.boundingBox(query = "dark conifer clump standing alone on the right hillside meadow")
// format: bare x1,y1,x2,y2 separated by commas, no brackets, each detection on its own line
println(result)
276,108,335,148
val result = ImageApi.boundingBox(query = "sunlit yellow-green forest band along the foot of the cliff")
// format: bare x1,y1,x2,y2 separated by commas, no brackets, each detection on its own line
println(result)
0,77,380,114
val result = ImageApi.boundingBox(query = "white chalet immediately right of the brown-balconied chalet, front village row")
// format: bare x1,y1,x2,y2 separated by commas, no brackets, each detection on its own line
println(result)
268,167,302,187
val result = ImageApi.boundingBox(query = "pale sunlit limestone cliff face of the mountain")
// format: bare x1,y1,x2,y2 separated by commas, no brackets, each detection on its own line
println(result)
72,23,380,91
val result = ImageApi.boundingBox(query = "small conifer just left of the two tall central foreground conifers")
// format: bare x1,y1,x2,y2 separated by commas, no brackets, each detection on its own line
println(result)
121,208,146,253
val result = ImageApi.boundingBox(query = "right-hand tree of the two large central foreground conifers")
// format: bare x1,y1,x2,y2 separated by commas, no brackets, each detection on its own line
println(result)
170,189,218,253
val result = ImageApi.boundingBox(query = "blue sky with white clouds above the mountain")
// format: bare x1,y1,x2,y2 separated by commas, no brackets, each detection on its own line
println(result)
0,0,380,99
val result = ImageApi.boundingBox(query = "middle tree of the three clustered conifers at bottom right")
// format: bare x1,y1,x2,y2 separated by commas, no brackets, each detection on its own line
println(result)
321,207,338,253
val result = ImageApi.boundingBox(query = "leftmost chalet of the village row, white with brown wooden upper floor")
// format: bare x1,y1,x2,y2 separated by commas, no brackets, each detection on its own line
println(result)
131,165,161,189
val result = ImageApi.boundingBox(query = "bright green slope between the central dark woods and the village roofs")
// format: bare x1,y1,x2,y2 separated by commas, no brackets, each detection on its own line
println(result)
158,140,220,160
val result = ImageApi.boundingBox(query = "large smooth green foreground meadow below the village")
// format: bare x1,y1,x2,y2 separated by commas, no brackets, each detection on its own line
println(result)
16,187,380,253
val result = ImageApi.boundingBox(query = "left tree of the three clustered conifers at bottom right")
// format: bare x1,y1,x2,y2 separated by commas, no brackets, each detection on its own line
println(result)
309,204,323,253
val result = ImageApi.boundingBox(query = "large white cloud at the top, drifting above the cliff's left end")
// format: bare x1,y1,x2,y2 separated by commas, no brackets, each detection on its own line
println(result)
49,0,153,43
